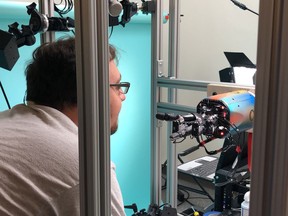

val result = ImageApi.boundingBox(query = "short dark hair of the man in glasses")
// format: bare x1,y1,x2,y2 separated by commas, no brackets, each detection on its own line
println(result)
25,38,117,111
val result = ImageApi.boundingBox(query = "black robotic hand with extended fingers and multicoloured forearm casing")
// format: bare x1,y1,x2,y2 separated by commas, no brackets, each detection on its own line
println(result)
156,90,255,146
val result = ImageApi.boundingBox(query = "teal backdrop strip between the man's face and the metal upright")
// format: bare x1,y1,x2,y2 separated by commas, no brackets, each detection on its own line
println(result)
110,20,151,215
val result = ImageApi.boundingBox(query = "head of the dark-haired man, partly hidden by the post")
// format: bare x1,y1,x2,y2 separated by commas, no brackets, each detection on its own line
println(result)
25,38,125,134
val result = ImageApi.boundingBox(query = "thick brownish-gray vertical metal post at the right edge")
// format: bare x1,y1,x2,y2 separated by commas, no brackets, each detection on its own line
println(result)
250,0,288,216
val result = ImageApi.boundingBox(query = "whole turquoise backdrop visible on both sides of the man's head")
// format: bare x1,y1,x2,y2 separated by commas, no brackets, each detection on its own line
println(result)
0,1,151,215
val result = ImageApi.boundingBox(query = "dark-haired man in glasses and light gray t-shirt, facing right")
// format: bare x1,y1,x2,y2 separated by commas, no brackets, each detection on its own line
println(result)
0,38,130,216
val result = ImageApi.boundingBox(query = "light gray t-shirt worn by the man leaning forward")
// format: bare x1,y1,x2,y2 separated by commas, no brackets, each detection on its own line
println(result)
0,104,125,216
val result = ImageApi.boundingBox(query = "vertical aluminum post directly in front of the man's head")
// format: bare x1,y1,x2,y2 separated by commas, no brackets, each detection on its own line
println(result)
75,0,111,216
